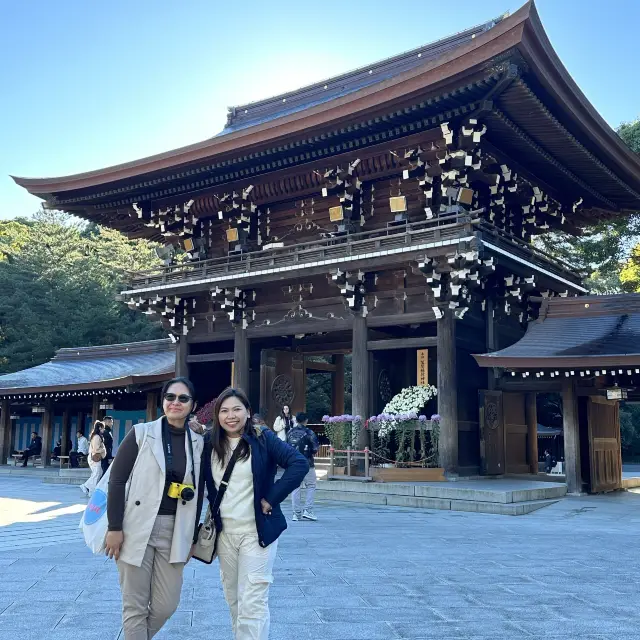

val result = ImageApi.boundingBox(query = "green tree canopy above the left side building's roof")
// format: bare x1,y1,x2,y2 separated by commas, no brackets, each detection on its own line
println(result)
0,212,163,373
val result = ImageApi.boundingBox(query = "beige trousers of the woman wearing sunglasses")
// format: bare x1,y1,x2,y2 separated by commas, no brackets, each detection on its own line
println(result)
118,516,184,640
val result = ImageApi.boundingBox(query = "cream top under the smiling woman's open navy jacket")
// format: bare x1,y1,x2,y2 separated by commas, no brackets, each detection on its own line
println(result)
211,438,256,533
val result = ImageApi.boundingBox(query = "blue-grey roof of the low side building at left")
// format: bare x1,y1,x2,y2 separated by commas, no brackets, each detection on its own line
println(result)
0,339,175,396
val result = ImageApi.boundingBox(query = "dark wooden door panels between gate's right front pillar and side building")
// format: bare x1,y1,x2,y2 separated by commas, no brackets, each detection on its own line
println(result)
479,390,538,475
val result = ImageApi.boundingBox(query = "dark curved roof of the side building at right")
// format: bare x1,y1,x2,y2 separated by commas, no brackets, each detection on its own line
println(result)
474,294,640,370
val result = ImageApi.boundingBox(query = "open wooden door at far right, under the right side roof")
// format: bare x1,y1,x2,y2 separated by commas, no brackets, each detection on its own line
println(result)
581,396,622,493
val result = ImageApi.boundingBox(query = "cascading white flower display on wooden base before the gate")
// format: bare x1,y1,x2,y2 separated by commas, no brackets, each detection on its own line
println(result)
367,385,444,482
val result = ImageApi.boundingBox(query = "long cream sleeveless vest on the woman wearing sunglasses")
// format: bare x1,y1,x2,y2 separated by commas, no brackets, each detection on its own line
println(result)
120,418,204,567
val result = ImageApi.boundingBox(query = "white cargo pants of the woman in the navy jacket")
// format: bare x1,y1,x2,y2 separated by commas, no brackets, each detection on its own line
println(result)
218,530,278,640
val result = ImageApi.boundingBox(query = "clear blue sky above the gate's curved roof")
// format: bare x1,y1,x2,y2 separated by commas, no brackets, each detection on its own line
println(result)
0,0,640,218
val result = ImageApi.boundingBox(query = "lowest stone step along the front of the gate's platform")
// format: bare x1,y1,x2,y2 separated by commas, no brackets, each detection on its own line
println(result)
316,490,560,516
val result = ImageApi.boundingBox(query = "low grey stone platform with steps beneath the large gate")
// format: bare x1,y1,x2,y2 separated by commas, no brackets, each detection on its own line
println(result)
316,478,567,516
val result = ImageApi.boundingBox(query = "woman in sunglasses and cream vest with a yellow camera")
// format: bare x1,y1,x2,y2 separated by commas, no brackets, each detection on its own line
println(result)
105,378,204,640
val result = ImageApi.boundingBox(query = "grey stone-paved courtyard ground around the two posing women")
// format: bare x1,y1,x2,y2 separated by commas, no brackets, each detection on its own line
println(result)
0,476,640,640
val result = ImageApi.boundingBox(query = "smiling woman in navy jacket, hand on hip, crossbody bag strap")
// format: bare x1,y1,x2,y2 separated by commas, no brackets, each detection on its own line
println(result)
202,388,309,640
